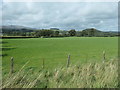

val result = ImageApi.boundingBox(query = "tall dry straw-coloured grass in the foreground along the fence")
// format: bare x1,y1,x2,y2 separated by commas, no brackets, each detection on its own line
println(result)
2,60,118,88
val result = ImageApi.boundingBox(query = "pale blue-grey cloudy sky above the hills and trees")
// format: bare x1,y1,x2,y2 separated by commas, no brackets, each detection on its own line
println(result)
2,2,118,31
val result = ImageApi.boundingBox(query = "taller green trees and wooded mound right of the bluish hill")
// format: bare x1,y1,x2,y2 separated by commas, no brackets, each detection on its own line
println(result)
32,28,118,37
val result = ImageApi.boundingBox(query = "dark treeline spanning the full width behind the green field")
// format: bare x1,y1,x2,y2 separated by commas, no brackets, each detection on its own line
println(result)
2,28,119,38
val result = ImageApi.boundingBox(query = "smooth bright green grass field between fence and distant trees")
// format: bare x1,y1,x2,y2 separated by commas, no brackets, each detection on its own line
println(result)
2,37,118,74
